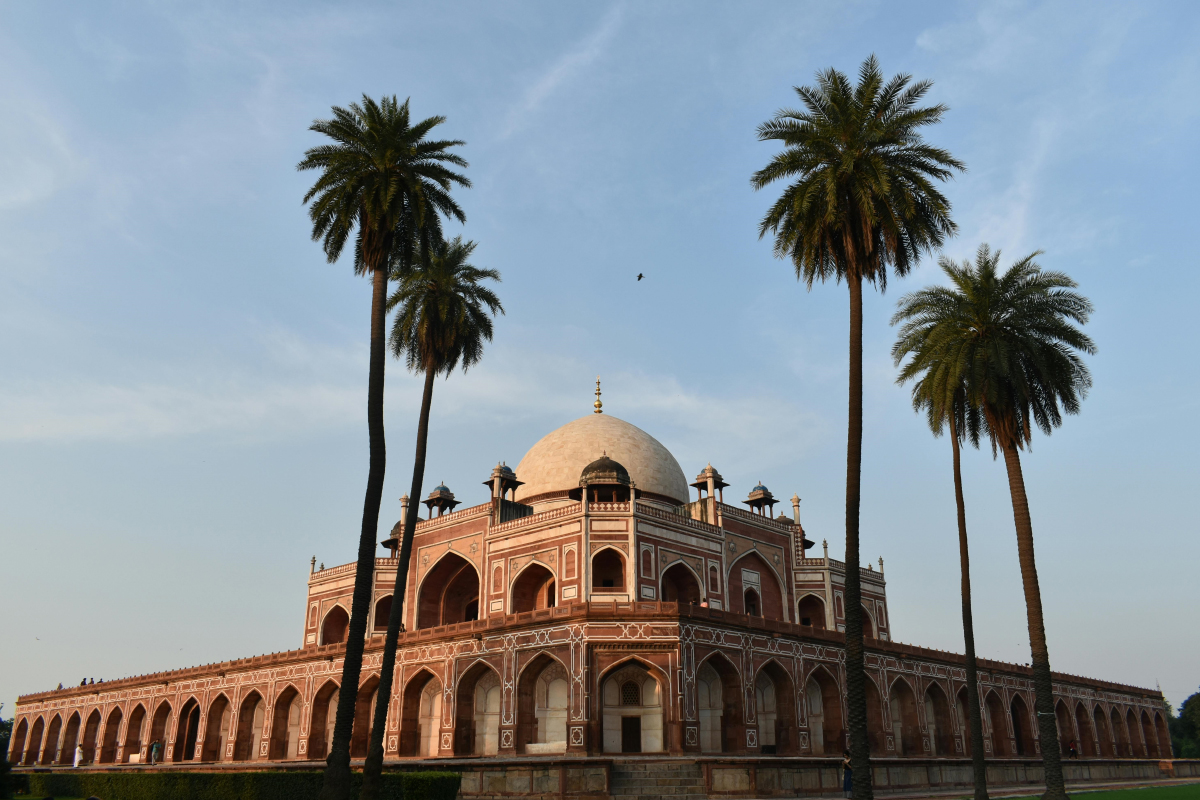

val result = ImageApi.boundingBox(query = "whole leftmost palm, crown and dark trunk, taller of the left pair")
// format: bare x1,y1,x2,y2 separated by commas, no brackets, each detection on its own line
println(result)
296,95,470,800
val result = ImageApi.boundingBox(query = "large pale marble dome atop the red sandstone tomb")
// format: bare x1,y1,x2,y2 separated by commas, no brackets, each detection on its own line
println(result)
517,414,689,503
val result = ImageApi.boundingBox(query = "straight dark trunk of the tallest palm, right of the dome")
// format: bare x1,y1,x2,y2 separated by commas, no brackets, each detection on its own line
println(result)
846,275,875,800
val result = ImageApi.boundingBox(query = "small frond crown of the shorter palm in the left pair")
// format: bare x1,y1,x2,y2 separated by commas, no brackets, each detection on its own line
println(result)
388,236,504,375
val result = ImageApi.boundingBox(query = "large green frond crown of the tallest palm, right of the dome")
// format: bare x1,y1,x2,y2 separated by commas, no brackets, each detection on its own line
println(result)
751,55,965,289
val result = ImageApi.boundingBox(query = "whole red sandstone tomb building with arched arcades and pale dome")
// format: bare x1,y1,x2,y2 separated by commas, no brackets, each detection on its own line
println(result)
10,415,1171,765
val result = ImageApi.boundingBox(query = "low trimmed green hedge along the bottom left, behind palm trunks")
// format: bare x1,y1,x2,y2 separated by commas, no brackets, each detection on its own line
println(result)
29,771,462,800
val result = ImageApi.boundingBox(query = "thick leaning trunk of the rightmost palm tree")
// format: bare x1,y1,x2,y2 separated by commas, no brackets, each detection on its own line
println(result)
1003,444,1067,800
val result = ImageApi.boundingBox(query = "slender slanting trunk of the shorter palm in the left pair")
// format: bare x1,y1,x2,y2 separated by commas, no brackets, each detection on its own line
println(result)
359,368,437,800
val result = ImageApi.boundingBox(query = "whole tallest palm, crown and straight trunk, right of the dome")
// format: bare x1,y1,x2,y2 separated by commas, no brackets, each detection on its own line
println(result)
751,55,964,800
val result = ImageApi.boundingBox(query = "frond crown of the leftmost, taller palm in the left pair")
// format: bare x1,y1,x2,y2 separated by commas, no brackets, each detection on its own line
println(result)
296,95,470,273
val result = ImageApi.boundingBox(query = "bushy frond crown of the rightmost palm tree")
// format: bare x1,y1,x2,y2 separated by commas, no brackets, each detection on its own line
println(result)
893,245,1096,450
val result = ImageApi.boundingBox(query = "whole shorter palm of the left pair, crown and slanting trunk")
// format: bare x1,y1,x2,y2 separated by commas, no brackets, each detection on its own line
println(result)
361,236,504,800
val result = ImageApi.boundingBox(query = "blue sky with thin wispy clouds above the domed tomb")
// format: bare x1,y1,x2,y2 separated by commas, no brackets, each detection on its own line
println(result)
0,0,1200,715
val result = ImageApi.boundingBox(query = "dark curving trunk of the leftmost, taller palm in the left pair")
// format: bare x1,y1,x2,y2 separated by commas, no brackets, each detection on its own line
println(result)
320,266,388,800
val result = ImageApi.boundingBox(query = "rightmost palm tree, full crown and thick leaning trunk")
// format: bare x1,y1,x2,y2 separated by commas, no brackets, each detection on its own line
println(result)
897,245,1096,800
